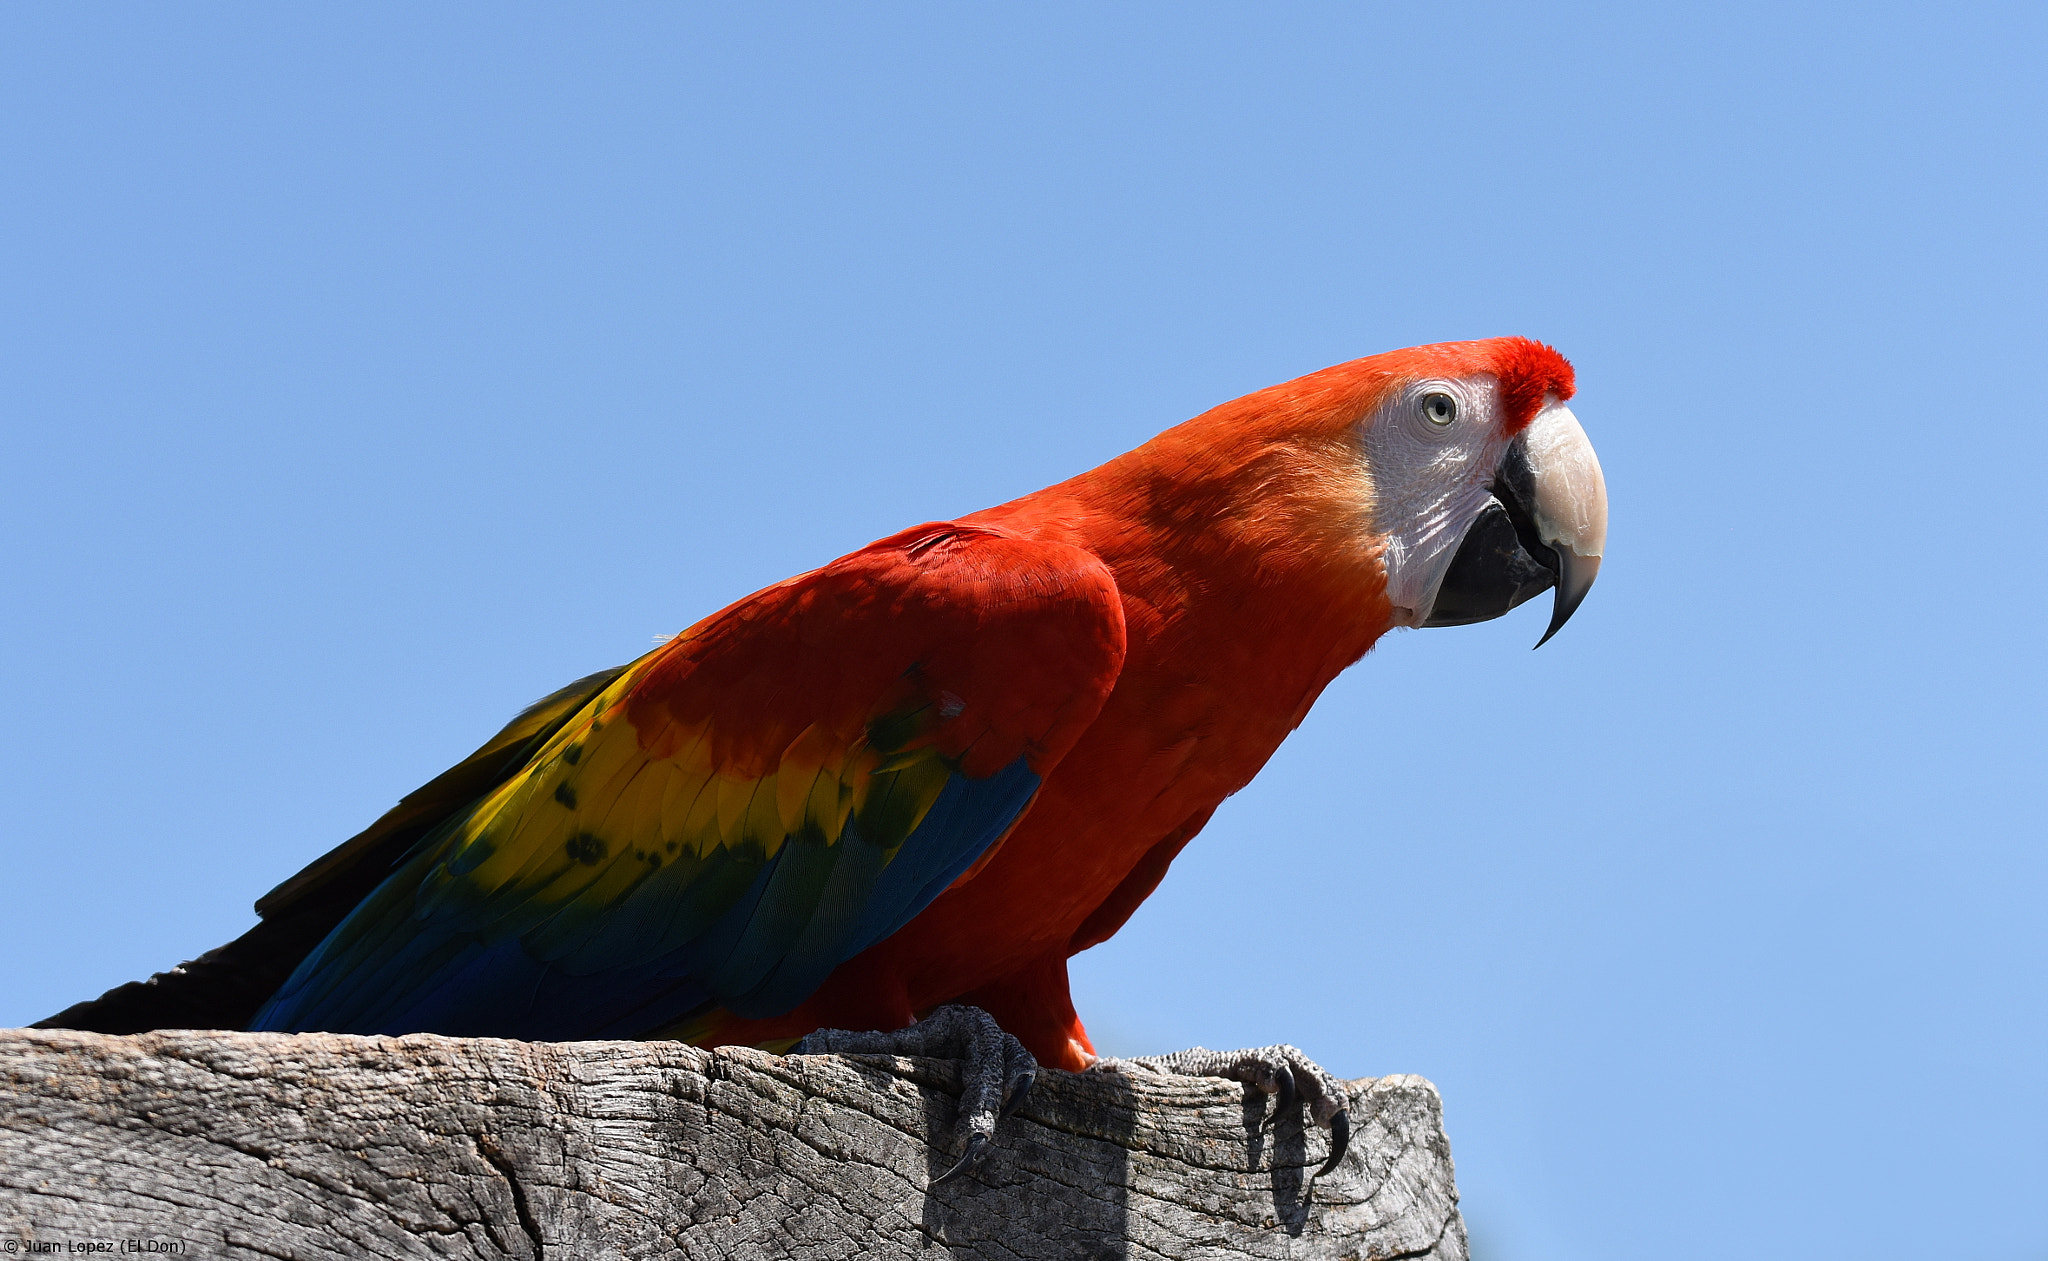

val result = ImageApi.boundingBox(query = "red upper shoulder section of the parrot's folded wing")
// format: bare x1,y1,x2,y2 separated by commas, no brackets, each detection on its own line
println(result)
625,522,1122,778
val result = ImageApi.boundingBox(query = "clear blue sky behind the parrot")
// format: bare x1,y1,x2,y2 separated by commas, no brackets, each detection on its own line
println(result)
0,4,2048,1261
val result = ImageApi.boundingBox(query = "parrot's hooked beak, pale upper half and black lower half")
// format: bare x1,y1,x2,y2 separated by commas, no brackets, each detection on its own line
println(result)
1423,403,1608,647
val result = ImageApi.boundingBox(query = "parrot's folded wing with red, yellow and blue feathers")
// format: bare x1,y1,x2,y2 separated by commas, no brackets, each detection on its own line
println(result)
254,524,1124,1038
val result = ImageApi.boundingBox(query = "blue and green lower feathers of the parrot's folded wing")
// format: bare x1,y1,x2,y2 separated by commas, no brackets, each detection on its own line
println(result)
250,759,1038,1038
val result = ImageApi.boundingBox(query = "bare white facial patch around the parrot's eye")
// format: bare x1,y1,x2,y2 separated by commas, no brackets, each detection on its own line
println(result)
1364,375,1507,626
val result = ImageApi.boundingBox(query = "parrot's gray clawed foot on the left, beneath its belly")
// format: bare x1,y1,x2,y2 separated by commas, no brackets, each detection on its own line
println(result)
791,1007,1038,1187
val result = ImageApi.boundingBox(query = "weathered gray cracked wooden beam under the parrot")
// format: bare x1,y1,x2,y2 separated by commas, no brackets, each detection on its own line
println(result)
0,1030,1466,1261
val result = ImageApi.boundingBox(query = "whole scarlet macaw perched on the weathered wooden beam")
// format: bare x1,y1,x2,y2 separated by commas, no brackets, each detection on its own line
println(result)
41,338,1608,1177
